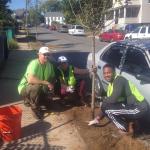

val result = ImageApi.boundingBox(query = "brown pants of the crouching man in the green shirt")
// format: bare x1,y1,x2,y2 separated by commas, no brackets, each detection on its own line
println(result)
21,84,48,109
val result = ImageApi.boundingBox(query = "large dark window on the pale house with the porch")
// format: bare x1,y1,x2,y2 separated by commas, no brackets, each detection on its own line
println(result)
126,7,140,18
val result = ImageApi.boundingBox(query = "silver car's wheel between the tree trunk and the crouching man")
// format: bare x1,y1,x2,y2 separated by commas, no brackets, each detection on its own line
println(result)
95,75,103,99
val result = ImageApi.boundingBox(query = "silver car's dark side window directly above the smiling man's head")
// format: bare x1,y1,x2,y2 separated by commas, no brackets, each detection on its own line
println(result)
101,45,123,68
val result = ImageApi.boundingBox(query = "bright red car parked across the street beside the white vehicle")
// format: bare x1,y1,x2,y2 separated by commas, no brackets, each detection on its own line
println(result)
99,29,125,42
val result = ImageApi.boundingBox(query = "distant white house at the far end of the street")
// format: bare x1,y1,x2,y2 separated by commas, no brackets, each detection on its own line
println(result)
45,12,65,26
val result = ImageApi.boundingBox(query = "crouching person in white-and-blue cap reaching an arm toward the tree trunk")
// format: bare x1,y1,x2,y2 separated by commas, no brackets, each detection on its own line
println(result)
58,56,89,104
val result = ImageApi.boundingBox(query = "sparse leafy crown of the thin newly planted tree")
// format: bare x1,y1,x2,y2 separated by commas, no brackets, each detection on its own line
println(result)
62,0,112,29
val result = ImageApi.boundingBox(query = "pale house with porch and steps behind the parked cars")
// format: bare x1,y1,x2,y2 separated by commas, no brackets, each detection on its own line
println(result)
105,0,150,30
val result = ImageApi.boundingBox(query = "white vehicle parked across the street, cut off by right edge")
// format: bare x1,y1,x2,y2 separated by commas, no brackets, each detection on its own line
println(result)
125,26,150,39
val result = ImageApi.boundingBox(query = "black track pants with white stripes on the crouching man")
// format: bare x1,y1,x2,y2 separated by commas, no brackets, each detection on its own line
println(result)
101,101,149,131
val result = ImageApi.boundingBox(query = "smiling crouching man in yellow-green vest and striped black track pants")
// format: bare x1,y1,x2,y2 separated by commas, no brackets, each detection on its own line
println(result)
89,64,149,132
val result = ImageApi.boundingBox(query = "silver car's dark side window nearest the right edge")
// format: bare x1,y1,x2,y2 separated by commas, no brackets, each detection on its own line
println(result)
123,48,149,74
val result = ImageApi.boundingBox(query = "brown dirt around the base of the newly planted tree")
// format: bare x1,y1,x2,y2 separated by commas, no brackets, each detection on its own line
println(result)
67,107,150,150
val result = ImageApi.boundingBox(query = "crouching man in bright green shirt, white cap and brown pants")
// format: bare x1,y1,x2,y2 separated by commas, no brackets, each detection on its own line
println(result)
18,47,55,119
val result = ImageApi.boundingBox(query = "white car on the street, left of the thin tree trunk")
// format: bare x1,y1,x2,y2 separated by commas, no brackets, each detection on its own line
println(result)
68,25,85,35
